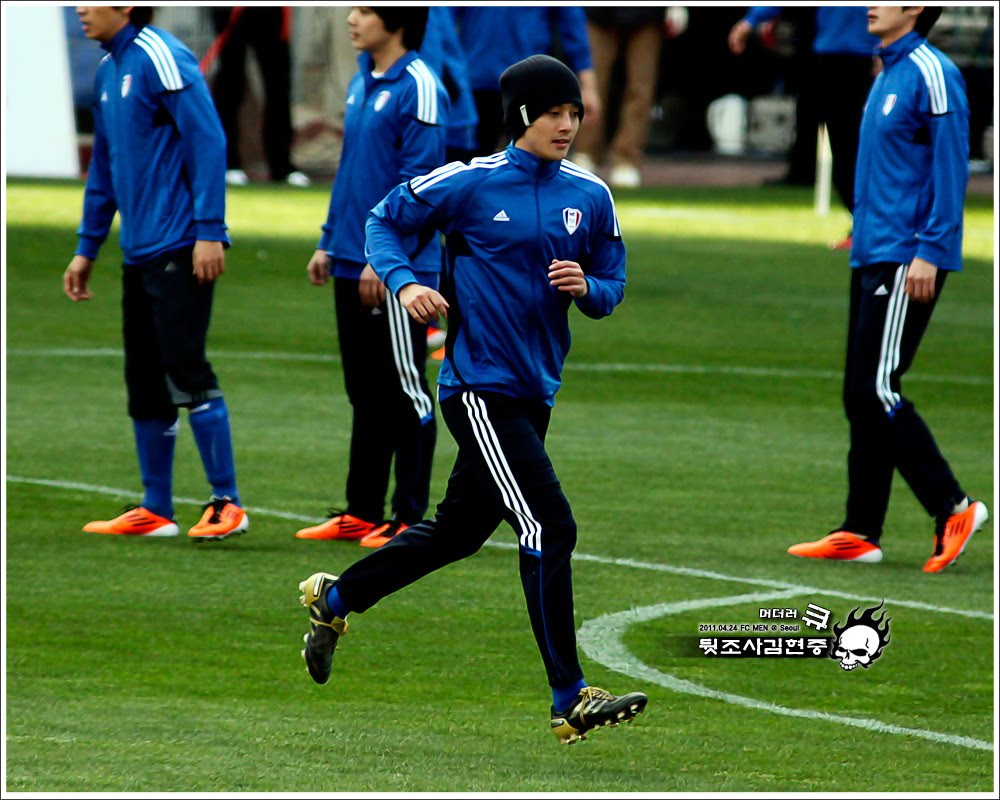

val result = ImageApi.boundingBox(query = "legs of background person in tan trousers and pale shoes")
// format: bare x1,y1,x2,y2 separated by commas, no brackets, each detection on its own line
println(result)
572,6,664,187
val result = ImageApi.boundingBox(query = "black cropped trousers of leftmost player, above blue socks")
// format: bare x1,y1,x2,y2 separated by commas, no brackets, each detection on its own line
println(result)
122,248,222,421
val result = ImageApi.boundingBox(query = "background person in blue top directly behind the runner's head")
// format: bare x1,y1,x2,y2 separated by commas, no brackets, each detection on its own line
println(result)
453,6,602,155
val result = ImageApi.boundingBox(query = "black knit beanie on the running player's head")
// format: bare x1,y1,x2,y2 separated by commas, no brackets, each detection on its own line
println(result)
500,56,584,142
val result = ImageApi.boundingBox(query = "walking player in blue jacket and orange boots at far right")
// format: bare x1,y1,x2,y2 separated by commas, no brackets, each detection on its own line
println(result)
788,6,989,572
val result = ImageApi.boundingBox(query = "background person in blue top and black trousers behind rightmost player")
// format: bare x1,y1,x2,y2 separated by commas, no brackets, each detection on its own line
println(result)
729,6,878,250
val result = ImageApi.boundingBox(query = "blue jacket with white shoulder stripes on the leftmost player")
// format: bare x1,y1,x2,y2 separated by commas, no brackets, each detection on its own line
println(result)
76,24,229,264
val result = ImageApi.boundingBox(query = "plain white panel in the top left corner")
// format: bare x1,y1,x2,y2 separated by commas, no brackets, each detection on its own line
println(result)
3,3,80,178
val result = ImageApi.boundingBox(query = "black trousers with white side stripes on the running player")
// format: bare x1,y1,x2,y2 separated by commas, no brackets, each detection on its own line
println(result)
337,391,583,687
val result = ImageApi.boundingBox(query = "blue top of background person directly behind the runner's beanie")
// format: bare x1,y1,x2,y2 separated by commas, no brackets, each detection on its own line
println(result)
453,5,593,92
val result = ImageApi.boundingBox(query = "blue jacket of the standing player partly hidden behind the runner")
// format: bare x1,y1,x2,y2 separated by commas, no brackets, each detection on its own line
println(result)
316,50,448,286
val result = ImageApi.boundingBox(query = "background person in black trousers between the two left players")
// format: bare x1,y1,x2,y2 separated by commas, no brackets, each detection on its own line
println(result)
202,6,310,186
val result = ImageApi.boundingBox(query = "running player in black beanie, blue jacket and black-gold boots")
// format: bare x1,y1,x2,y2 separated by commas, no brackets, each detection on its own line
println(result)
299,56,647,743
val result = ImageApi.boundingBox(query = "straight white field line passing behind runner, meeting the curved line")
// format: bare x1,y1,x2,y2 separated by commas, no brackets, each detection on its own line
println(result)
7,475,993,620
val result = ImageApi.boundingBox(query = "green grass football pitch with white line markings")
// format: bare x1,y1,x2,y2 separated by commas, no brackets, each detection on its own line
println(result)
4,181,997,794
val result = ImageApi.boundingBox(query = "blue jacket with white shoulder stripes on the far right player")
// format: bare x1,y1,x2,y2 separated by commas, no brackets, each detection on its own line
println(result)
851,32,969,271
